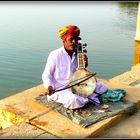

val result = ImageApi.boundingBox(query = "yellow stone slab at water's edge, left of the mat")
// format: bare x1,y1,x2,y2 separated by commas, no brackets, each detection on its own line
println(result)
0,84,49,119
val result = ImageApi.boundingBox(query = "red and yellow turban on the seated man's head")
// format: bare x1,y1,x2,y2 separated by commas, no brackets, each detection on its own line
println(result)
58,25,80,40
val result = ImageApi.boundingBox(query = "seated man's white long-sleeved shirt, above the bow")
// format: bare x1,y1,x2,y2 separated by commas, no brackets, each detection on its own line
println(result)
42,46,76,89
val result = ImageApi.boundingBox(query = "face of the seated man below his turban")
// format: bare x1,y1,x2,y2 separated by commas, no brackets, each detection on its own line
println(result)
63,36,78,51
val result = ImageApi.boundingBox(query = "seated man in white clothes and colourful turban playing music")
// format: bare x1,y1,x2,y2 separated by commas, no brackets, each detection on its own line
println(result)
42,25,107,109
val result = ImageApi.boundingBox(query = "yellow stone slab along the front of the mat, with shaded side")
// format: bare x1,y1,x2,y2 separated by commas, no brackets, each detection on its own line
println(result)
31,111,130,138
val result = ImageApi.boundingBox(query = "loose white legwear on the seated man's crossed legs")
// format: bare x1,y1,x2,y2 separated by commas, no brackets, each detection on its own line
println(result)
47,82,108,109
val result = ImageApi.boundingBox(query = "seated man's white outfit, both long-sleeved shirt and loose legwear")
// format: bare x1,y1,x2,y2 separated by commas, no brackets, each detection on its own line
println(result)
42,46,107,109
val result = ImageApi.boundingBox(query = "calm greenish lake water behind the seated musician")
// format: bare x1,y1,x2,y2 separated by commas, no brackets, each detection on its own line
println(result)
0,1,138,99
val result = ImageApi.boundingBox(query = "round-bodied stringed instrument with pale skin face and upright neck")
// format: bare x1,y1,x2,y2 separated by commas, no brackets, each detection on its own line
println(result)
69,43,96,97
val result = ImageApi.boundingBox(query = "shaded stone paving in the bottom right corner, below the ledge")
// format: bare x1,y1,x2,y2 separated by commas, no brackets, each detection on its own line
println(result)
98,110,140,138
